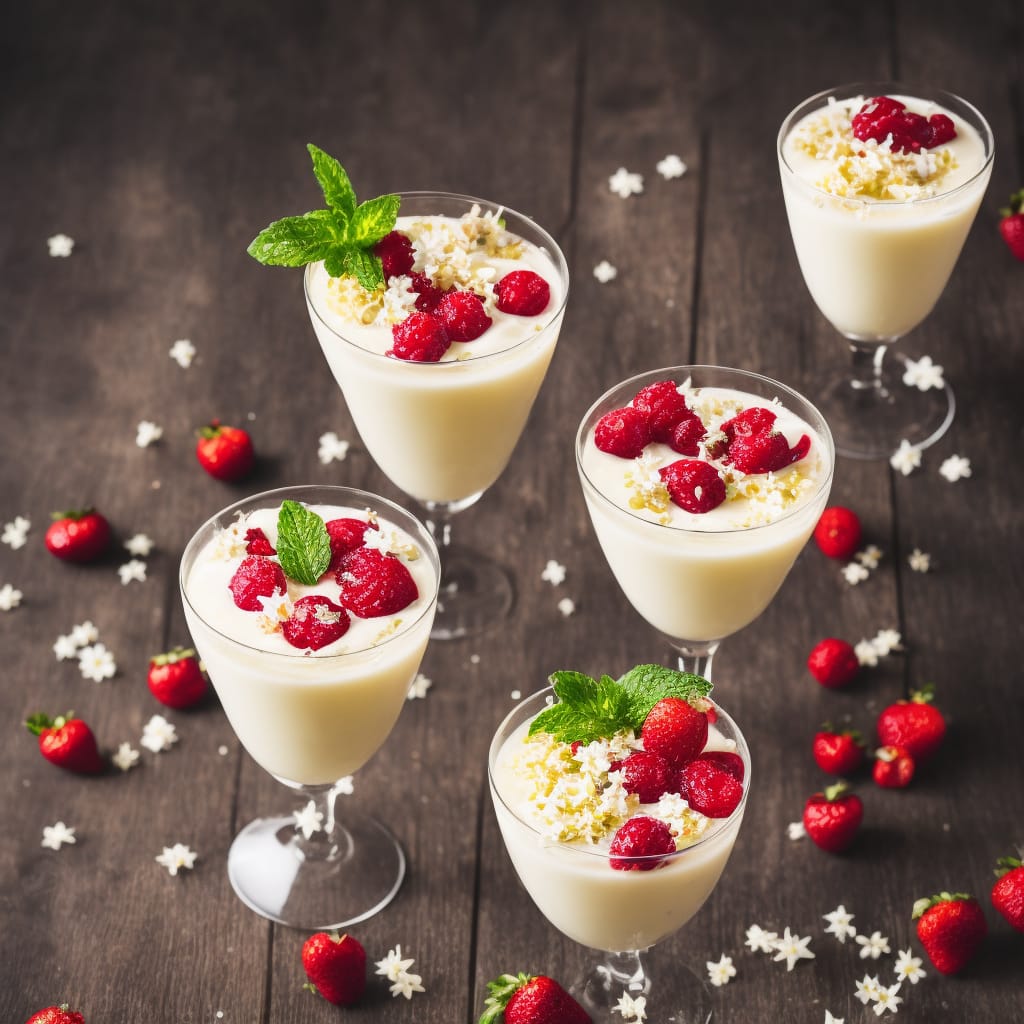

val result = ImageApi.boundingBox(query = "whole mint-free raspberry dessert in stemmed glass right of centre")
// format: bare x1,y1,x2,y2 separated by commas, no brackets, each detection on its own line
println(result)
575,366,836,679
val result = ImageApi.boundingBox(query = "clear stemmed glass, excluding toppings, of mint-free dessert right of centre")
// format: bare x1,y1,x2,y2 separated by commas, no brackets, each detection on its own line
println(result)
575,366,836,679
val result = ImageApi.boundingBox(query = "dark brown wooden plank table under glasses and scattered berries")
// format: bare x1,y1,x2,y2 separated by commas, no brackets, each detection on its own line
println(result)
0,0,1024,1024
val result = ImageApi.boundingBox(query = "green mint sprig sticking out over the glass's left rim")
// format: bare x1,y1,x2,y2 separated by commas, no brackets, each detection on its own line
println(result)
247,142,399,292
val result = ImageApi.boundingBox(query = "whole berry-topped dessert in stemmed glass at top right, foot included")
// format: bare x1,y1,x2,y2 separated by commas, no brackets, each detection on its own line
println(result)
778,82,993,459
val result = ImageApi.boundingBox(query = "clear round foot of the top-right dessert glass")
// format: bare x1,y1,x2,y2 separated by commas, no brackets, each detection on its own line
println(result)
809,351,956,459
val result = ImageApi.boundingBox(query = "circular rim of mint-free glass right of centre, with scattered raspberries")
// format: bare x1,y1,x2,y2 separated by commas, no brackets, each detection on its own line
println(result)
575,364,836,538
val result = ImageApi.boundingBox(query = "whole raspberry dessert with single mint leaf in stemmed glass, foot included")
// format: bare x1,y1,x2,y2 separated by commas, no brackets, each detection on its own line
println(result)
180,485,439,930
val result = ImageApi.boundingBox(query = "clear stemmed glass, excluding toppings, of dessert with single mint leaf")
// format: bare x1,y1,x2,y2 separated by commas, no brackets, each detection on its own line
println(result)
179,485,440,930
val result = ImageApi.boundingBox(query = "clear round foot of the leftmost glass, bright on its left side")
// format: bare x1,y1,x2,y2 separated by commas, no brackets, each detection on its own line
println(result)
227,814,406,932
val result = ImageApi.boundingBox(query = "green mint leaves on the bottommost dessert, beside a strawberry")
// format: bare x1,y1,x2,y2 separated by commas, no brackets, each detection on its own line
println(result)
529,665,712,743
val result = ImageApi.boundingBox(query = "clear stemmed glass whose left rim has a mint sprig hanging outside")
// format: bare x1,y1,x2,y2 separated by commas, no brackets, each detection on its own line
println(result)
304,191,568,639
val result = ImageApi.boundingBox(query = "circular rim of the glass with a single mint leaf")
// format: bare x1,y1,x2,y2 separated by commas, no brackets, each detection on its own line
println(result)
178,483,440,667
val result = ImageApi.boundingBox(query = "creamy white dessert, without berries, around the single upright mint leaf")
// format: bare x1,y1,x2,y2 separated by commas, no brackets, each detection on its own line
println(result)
182,505,437,785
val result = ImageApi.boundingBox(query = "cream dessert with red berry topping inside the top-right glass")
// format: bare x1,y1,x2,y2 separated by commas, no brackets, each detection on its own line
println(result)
778,93,992,341
